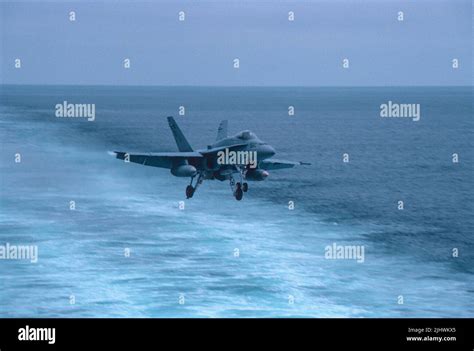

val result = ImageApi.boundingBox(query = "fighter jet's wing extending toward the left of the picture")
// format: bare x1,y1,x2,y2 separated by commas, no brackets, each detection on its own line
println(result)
112,151,203,168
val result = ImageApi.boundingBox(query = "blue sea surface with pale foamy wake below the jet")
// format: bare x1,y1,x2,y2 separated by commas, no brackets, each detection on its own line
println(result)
0,86,474,317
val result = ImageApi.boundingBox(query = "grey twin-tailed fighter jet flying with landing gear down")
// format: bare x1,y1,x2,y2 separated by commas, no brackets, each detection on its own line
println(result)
113,117,309,201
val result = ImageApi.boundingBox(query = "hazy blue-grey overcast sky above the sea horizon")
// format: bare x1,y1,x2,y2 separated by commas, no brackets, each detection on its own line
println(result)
0,0,473,86
